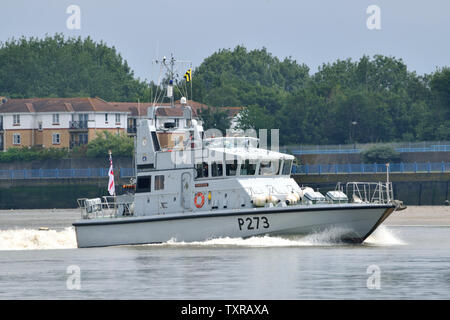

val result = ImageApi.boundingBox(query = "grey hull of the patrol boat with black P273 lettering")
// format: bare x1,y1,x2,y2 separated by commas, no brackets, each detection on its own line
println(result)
74,204,395,248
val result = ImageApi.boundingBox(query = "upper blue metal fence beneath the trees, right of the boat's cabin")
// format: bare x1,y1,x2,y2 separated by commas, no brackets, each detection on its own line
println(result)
280,141,450,155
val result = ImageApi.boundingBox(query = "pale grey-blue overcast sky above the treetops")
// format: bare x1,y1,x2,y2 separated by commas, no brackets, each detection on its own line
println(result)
0,0,450,79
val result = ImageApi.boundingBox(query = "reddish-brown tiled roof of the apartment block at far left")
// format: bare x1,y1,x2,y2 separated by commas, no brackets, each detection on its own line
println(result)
0,98,129,113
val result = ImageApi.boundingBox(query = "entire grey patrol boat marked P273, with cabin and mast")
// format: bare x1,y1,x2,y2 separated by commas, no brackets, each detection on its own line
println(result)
73,57,402,248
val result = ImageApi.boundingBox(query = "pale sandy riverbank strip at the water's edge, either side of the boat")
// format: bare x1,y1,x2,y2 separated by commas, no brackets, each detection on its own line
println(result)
0,206,450,230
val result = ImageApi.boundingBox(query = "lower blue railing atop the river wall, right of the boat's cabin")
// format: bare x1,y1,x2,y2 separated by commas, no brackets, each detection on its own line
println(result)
292,162,450,174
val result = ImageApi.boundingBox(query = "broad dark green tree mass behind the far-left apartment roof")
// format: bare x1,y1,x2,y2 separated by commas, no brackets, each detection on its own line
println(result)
0,34,149,101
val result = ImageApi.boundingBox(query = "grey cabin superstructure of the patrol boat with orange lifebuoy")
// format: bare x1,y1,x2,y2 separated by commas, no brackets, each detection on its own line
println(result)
134,106,301,216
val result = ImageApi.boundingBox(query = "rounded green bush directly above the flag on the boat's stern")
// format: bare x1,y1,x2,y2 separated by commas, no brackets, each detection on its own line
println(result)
86,131,134,158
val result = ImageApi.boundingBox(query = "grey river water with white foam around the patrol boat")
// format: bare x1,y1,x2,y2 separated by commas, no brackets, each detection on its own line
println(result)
0,211,450,300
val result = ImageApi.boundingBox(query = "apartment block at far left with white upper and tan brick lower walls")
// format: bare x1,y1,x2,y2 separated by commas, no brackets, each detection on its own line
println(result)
0,98,127,150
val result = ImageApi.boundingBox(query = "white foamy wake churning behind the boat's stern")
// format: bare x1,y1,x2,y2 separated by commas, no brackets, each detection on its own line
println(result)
0,227,77,250
